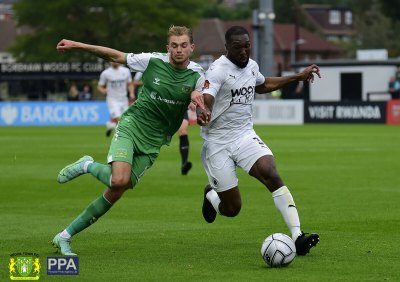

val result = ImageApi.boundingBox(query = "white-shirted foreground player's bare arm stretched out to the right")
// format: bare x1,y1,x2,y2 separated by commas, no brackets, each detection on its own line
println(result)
256,64,321,93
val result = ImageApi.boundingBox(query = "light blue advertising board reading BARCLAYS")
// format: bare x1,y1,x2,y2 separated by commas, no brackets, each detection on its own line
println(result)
0,101,110,126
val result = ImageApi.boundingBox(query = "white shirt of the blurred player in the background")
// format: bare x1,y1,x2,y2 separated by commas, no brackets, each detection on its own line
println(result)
99,66,132,101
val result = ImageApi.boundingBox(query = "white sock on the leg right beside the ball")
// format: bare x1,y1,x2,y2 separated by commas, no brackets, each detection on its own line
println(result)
272,186,301,241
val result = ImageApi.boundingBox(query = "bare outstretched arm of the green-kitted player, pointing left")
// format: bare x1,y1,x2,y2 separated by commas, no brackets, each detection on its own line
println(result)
56,39,126,64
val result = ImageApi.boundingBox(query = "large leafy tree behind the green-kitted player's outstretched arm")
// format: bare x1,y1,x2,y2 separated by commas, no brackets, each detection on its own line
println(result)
9,0,209,61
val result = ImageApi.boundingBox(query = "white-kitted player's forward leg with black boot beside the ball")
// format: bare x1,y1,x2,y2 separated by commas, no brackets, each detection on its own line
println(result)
249,142,319,255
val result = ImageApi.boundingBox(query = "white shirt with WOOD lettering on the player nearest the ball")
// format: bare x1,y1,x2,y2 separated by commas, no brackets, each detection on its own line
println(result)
201,55,265,144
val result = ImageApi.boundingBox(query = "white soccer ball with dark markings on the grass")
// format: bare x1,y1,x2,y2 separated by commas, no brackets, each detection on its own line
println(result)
261,233,296,267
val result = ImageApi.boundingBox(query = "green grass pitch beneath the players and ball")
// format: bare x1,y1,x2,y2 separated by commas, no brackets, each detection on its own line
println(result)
0,125,400,281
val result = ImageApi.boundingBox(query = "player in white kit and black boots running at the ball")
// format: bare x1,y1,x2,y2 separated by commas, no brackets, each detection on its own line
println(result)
198,26,320,255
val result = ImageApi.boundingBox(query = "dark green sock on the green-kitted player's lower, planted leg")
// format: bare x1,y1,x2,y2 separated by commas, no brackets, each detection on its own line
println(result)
66,195,112,236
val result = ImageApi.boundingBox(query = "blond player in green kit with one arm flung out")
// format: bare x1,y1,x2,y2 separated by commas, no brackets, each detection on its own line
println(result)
52,26,204,255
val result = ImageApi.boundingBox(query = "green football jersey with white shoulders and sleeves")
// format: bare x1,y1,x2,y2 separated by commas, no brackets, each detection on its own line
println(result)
118,53,204,153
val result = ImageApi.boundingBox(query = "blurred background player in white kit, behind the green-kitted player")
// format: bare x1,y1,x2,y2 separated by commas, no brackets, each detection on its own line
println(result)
97,62,135,136
